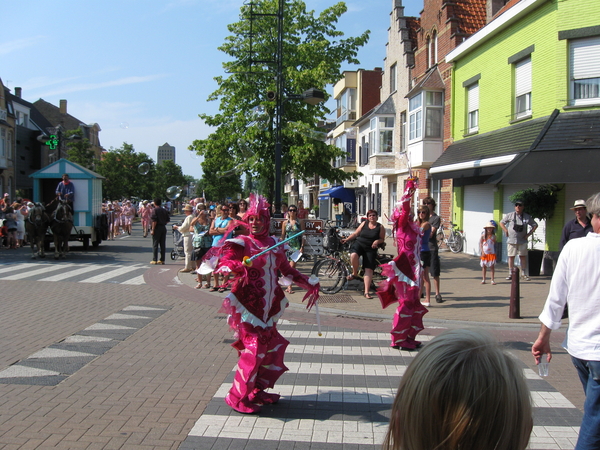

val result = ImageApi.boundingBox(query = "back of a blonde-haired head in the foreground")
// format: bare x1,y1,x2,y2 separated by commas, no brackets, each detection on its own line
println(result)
383,330,533,450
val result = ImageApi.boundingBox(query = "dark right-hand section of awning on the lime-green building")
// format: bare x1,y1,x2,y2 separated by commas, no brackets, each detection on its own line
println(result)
486,110,600,184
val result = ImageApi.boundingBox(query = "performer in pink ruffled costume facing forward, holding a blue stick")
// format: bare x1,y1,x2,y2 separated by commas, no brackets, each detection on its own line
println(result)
215,195,319,413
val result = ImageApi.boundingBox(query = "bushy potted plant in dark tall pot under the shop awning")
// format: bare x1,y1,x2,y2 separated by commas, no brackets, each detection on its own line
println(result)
508,184,560,276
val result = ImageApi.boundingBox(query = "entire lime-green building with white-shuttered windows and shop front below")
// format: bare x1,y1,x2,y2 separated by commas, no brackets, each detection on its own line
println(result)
432,0,600,260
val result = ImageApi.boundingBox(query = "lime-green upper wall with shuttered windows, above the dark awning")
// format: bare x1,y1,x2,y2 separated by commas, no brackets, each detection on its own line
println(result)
452,0,600,140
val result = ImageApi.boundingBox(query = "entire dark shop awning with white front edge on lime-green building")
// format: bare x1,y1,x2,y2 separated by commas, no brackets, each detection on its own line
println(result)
430,110,600,185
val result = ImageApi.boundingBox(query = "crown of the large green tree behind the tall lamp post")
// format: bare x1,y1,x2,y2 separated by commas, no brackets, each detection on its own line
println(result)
189,0,369,203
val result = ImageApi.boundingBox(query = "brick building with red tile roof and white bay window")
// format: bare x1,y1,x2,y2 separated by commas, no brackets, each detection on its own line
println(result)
406,0,488,220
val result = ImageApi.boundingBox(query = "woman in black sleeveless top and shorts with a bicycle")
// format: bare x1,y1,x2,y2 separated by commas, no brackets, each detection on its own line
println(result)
341,209,385,298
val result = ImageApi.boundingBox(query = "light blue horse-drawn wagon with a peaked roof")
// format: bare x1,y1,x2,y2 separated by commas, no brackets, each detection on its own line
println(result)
30,159,108,254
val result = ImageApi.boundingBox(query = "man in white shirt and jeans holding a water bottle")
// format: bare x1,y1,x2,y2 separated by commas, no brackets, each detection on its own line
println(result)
531,193,600,450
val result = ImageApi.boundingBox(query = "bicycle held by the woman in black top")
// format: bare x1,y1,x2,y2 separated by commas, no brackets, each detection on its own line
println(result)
311,229,394,294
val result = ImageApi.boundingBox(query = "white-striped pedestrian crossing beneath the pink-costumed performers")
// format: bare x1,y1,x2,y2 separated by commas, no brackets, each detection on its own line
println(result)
180,322,581,449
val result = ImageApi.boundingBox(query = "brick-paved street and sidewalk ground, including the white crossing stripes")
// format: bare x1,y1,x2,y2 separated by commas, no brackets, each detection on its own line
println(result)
0,239,583,449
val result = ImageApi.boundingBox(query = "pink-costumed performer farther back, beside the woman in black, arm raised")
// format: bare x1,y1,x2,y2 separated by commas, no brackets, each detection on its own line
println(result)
377,178,427,351
